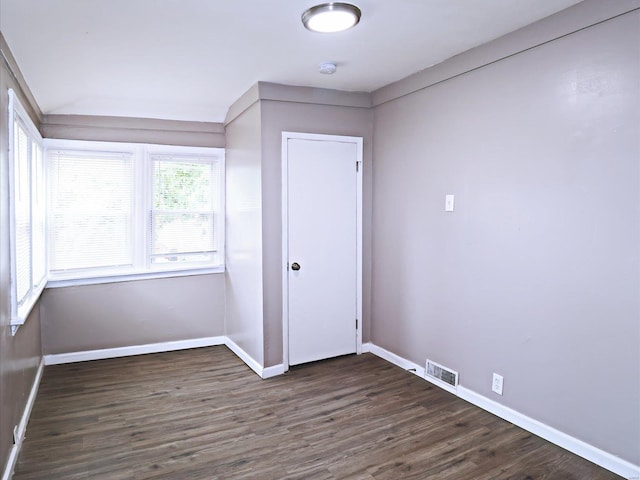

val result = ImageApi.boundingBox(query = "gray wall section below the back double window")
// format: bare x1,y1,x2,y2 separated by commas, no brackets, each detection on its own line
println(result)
40,274,225,354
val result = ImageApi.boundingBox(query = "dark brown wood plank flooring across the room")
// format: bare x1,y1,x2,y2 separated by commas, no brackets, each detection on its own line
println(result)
13,346,620,480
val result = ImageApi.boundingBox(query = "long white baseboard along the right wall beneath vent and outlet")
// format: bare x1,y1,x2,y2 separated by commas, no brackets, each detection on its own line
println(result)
362,343,640,480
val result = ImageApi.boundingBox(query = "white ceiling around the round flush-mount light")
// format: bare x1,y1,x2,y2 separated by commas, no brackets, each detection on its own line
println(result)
0,0,580,122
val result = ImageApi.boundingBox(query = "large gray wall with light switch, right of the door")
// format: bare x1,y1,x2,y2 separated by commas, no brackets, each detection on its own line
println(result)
371,2,640,465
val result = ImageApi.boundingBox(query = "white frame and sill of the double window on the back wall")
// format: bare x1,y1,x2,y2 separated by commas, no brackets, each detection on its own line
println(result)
44,139,225,288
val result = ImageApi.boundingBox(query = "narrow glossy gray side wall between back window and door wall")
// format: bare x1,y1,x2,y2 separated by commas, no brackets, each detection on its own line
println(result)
225,103,264,365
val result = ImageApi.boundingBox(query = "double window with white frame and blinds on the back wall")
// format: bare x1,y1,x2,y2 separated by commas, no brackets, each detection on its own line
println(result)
46,140,224,280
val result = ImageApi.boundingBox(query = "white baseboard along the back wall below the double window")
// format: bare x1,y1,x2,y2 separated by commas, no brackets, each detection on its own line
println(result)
44,336,226,365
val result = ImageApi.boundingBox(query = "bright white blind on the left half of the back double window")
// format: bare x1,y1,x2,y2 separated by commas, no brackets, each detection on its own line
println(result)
48,150,134,273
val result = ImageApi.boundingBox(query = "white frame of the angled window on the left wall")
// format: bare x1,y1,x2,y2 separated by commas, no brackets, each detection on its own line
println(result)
7,89,47,335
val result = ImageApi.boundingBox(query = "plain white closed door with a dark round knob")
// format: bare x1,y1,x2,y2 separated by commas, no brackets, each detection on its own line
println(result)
283,133,362,365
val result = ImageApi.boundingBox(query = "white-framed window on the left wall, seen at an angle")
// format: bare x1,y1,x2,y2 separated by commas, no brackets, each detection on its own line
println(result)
8,90,46,333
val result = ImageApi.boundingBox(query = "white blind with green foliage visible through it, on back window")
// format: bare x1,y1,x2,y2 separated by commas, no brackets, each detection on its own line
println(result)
148,155,221,268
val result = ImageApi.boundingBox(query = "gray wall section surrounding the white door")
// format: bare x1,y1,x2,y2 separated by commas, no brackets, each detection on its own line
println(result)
261,99,373,366
